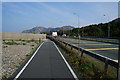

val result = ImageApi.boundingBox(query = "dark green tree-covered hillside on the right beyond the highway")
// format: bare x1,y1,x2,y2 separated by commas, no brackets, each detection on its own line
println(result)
58,18,120,37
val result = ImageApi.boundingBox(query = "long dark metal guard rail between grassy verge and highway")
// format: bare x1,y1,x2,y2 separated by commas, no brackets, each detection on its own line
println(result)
47,36,118,72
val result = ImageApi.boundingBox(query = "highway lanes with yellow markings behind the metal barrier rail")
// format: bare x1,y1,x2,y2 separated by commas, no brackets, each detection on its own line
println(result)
60,38,118,61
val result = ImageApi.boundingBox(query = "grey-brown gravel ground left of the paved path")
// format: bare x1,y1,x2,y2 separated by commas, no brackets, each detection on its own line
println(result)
2,40,37,78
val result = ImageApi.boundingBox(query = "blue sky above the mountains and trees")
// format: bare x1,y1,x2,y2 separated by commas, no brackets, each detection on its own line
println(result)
2,2,118,33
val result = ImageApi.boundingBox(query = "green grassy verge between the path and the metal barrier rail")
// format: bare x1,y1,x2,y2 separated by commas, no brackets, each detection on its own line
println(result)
53,39,117,80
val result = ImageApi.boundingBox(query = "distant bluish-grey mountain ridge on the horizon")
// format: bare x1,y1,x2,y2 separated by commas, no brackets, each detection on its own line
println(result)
22,26,74,34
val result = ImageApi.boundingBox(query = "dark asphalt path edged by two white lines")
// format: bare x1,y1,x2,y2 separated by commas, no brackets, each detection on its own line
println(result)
11,41,77,80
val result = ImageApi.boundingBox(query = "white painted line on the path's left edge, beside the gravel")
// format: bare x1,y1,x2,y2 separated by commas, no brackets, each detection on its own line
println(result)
14,42,44,80
